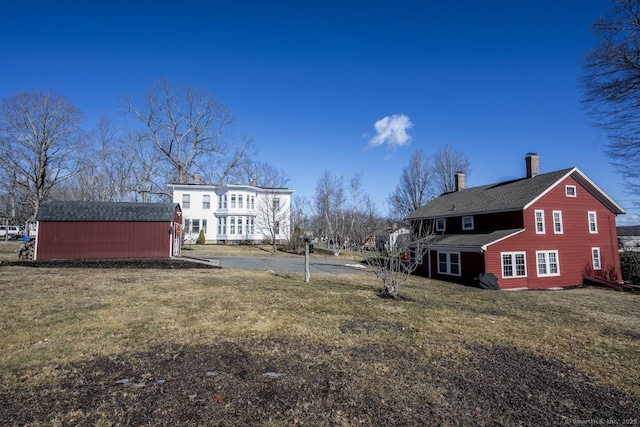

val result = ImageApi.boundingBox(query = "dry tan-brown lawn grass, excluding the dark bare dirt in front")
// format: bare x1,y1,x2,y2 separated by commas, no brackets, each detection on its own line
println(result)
0,251,640,425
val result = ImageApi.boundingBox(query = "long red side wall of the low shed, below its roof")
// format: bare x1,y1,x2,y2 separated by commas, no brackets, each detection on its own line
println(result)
36,221,172,260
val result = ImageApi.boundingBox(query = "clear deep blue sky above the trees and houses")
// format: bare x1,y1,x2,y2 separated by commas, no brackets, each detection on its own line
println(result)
0,0,640,223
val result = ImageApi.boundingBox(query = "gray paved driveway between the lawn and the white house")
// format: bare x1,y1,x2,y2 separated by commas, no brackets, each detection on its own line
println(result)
201,256,367,274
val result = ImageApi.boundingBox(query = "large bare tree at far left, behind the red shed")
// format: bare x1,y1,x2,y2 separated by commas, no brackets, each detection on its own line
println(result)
0,92,85,214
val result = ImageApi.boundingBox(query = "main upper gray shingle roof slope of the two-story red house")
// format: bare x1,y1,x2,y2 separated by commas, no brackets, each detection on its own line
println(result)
409,168,574,219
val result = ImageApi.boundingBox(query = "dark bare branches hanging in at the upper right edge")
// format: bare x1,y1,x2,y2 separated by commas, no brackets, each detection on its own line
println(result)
582,0,640,192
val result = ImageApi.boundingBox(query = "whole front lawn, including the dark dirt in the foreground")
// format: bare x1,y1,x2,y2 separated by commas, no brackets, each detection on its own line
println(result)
0,243,640,426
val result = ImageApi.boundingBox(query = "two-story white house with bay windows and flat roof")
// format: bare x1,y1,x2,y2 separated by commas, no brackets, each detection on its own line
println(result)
169,179,294,243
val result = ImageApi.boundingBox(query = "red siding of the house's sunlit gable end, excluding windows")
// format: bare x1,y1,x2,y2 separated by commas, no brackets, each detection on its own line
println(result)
485,177,621,289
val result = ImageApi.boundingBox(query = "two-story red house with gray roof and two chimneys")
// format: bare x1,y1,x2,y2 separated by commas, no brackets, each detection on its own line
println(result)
409,153,624,289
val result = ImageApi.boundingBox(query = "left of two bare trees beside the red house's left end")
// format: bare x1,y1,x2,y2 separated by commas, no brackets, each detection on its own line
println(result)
389,150,434,219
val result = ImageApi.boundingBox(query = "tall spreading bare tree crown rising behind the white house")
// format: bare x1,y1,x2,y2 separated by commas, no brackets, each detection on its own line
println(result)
127,80,251,188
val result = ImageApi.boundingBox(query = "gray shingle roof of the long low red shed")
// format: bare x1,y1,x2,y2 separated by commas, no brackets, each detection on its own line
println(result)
36,201,177,222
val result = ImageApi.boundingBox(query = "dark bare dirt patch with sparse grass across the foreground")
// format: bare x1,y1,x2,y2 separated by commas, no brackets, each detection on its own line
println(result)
0,339,640,426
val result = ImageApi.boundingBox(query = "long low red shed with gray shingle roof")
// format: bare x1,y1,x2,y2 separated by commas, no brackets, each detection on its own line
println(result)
34,202,182,260
